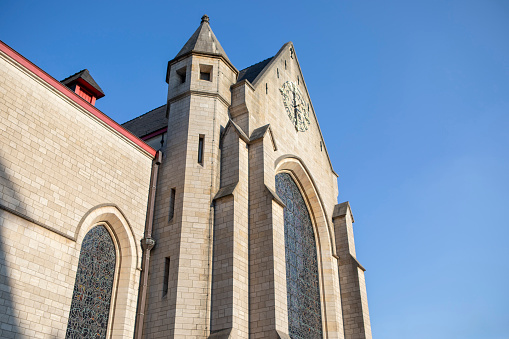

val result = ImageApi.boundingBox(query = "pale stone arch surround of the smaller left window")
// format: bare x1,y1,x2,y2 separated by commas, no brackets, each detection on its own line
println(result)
75,204,141,337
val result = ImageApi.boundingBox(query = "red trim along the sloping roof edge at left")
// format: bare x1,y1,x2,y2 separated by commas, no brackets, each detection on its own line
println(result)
0,40,156,156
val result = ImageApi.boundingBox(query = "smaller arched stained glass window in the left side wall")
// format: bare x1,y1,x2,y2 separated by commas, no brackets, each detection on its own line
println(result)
65,226,116,339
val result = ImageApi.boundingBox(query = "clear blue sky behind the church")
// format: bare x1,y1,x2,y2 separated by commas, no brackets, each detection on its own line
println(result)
0,0,509,339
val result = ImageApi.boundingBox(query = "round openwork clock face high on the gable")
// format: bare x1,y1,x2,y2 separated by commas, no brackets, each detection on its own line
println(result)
279,81,310,132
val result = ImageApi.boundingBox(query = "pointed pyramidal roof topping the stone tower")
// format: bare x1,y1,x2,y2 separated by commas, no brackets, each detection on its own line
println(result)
175,15,231,63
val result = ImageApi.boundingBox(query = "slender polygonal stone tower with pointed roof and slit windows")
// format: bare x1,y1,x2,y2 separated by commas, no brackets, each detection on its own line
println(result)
144,15,238,338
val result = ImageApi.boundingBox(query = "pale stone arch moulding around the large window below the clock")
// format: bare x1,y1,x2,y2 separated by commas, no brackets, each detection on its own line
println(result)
275,155,343,338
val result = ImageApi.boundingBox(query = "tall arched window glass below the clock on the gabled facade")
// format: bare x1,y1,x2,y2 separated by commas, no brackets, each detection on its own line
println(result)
276,173,322,339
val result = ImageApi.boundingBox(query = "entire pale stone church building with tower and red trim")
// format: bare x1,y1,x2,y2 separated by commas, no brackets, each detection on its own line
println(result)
0,15,372,339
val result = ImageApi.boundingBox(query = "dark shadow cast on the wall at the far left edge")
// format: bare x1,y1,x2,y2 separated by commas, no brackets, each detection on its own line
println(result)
0,158,22,338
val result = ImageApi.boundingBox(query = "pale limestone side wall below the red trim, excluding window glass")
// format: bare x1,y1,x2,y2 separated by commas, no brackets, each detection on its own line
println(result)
0,49,152,338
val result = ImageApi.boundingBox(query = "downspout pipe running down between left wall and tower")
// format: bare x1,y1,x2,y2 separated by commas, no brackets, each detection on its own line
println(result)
134,151,163,339
